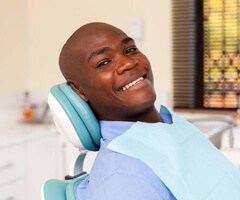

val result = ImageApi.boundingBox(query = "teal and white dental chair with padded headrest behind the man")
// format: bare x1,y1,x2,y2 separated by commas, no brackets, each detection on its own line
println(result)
42,83,101,200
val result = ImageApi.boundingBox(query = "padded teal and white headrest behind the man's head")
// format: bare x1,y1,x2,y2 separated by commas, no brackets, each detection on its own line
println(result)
48,83,101,151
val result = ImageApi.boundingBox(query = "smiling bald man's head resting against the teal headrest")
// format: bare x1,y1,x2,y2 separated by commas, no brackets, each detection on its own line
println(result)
59,23,156,121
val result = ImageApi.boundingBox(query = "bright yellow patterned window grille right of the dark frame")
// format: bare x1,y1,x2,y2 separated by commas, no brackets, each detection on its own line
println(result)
203,0,240,108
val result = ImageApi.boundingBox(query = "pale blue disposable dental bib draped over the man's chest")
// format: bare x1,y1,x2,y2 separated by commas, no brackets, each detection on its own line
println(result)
108,106,240,200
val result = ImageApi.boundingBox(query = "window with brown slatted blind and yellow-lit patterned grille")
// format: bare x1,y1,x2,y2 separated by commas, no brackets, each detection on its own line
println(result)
172,0,240,109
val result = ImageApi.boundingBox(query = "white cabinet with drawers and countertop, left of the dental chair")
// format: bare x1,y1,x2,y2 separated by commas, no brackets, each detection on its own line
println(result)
0,124,83,200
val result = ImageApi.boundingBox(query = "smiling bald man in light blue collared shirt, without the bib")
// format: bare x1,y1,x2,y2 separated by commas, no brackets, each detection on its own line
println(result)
59,23,175,200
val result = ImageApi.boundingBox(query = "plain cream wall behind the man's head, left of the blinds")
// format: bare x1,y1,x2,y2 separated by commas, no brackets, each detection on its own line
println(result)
0,0,172,106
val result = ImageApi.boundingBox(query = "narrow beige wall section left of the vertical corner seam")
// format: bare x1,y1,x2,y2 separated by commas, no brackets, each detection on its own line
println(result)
0,0,25,93
